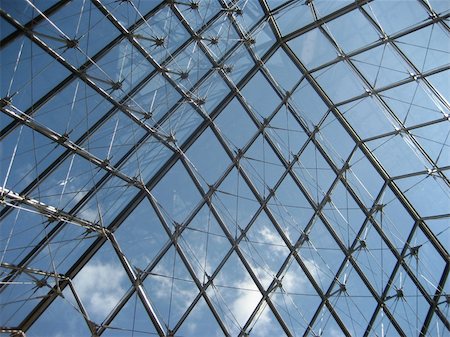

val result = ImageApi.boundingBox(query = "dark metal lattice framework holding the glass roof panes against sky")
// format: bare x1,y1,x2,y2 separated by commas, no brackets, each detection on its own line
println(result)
0,0,450,337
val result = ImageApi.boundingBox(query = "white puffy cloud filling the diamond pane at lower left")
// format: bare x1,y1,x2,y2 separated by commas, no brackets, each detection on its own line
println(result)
74,262,126,319
